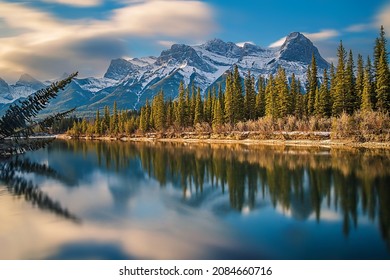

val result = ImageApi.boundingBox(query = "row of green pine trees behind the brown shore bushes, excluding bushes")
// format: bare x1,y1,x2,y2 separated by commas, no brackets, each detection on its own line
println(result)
70,26,390,135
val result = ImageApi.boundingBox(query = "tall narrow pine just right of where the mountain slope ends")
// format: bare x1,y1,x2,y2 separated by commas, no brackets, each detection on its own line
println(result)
332,41,347,116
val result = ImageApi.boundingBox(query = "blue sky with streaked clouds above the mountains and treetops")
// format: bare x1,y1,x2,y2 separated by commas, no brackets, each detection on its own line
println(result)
0,0,390,82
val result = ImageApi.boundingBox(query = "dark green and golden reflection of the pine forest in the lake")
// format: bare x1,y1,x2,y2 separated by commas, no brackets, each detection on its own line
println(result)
57,141,390,247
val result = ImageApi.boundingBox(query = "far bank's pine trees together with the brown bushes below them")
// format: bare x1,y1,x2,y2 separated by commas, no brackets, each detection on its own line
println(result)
68,27,390,142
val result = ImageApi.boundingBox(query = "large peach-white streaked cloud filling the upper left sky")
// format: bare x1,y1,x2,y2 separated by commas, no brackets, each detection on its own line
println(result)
0,0,216,81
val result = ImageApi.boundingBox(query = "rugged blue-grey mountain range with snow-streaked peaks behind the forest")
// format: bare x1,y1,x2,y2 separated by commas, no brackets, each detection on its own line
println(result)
0,32,329,114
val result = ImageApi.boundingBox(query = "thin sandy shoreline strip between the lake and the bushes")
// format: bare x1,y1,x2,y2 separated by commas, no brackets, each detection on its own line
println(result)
56,134,390,149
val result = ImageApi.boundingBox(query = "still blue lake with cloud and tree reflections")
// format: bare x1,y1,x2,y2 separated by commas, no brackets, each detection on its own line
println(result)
0,140,390,259
